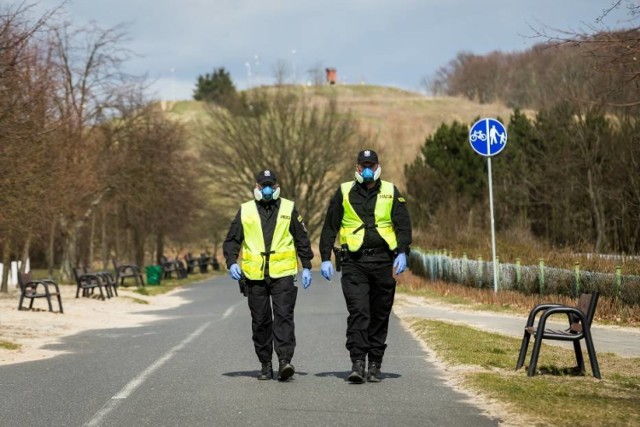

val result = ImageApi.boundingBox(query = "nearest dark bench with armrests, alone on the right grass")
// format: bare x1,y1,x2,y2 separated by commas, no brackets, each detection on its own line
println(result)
516,292,601,379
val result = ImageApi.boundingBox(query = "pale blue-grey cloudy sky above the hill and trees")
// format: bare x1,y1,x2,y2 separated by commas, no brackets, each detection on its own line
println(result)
27,0,633,100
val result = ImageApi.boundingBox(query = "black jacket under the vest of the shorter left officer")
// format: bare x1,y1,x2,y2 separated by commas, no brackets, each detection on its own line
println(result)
222,199,313,268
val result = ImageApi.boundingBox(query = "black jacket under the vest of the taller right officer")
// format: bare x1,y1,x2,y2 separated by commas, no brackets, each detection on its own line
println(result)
320,180,411,261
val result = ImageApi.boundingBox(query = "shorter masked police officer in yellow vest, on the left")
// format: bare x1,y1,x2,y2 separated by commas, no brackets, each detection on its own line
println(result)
222,170,313,381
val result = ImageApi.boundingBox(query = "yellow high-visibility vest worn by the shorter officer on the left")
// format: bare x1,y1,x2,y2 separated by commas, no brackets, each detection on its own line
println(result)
240,198,298,280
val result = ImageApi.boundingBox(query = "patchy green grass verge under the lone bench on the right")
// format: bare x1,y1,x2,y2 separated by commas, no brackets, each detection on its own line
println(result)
411,320,640,426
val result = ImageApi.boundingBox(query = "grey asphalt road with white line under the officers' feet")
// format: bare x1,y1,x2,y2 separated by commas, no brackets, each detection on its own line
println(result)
0,274,498,426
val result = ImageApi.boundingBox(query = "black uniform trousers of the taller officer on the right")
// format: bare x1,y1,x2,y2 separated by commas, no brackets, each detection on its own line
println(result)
341,257,396,363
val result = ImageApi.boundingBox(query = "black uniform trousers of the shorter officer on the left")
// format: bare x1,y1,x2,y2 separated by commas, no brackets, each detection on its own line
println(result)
247,276,298,363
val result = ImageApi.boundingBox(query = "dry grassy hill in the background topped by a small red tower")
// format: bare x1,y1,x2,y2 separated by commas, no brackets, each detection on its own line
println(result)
165,85,511,189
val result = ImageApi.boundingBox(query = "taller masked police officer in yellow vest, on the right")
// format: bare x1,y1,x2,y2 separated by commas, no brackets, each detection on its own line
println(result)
320,150,411,383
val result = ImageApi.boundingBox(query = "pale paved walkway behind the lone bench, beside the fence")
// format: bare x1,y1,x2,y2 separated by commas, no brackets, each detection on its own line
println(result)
394,294,640,357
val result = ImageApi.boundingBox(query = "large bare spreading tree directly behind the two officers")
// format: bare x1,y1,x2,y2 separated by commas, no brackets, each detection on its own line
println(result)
200,89,367,241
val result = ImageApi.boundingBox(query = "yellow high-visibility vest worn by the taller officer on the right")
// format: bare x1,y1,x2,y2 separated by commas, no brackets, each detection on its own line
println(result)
340,181,398,252
